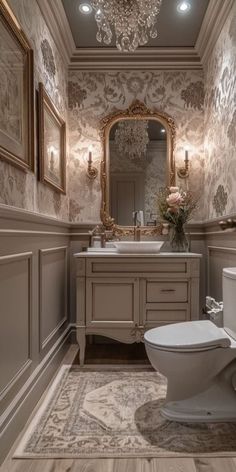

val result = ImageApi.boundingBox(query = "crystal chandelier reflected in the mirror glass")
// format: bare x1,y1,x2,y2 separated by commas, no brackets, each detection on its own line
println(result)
115,120,149,160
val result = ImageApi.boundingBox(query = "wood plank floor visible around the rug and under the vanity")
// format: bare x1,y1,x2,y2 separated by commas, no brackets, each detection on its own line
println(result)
0,345,236,472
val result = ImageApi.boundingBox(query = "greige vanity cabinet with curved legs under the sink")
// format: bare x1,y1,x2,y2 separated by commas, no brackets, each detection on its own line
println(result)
75,253,201,365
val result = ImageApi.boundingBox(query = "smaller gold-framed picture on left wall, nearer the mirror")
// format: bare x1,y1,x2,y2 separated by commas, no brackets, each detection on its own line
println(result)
39,83,66,193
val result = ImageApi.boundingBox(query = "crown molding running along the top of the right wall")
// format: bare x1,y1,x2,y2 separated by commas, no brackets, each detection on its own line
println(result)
195,0,235,66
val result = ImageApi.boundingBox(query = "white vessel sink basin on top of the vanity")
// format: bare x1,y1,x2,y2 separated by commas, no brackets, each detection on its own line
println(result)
114,241,164,254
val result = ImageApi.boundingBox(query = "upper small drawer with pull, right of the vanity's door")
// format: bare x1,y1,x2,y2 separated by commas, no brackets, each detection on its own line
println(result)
146,281,188,303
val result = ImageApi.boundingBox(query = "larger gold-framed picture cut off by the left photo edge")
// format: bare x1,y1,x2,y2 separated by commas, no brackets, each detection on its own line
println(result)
0,0,34,171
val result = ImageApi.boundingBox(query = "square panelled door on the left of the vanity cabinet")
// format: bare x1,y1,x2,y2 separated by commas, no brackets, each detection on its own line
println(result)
86,278,139,328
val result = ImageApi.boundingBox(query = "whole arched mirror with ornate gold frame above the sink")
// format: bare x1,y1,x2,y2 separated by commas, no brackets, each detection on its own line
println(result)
101,101,175,234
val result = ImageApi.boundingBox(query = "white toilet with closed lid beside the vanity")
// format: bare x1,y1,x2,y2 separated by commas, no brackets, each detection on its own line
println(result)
144,267,236,423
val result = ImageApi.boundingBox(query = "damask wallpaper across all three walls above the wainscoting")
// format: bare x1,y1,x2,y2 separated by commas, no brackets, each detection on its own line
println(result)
0,0,236,223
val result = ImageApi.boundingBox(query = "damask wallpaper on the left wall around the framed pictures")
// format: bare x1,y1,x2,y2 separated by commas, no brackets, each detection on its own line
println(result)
0,0,68,219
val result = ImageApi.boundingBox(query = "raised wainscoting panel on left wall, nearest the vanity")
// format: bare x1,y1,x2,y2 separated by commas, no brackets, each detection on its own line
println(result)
39,246,68,351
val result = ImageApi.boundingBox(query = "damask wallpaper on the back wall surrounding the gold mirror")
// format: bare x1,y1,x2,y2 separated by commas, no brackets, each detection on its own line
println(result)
68,71,204,222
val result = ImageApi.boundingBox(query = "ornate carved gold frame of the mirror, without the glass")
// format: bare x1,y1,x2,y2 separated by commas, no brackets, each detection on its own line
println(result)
100,100,176,236
